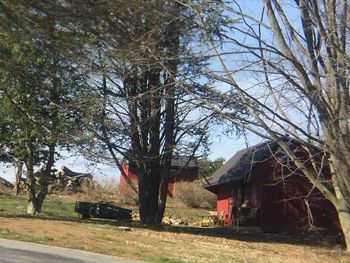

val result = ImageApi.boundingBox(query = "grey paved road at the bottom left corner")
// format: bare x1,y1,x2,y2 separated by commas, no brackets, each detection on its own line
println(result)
0,238,141,263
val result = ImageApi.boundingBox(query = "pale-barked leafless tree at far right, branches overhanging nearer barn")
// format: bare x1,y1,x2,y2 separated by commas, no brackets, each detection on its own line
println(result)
189,0,350,251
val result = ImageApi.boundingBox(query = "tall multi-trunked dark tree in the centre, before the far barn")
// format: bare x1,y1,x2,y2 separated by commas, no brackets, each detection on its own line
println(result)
73,0,221,224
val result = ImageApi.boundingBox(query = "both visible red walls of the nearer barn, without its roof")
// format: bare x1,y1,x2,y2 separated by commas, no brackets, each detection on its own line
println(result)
211,160,340,232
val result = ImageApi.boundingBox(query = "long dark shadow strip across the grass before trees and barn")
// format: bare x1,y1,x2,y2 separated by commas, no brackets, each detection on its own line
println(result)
0,211,345,252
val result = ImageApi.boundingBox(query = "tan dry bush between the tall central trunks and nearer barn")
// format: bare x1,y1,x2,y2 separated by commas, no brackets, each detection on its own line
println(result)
175,180,216,209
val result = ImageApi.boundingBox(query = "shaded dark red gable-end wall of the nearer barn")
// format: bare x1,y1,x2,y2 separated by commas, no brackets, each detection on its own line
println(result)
251,160,340,232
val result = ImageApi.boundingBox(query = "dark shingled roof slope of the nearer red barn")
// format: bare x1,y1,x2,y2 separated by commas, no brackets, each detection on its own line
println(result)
204,141,278,188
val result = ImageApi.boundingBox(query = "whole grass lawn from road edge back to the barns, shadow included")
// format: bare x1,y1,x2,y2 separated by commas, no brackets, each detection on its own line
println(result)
0,196,350,263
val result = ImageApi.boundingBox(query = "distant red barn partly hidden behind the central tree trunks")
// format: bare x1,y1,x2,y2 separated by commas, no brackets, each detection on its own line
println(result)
120,156,198,197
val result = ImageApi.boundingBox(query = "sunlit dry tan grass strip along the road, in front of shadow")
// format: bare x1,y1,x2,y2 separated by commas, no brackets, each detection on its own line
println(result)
0,218,350,263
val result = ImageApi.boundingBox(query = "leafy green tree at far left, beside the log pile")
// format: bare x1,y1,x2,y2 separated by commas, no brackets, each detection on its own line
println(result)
0,1,86,213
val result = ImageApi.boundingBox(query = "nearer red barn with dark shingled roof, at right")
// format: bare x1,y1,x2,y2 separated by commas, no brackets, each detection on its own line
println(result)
204,139,340,232
